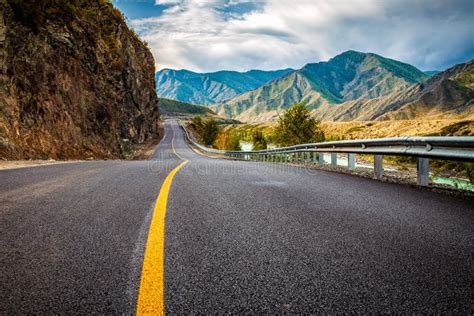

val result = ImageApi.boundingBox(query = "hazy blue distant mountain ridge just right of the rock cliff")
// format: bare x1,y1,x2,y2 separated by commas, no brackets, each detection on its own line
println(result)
156,69,292,104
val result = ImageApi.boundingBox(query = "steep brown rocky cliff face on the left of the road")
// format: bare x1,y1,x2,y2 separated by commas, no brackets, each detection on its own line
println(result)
0,0,159,159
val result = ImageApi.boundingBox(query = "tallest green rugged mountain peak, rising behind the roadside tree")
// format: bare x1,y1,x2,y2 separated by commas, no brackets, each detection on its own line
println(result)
213,51,429,121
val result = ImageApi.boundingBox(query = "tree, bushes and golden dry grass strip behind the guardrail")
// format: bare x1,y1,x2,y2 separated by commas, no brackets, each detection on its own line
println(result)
188,103,474,183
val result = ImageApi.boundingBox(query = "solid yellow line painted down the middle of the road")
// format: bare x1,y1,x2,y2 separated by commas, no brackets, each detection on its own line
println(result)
137,160,188,315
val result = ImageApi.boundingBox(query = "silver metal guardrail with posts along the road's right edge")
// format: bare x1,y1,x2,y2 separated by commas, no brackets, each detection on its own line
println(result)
179,122,474,185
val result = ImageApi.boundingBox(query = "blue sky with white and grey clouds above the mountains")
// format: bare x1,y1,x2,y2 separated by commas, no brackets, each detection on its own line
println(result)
113,0,474,72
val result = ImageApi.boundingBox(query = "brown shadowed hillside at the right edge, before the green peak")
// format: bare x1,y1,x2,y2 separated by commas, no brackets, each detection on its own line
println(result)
314,60,474,121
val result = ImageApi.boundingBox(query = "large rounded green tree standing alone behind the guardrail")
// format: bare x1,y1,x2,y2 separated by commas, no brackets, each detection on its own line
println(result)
274,102,324,146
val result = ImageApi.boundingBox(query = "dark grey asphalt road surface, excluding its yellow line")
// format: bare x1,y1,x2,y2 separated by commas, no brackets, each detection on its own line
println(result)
0,122,474,314
